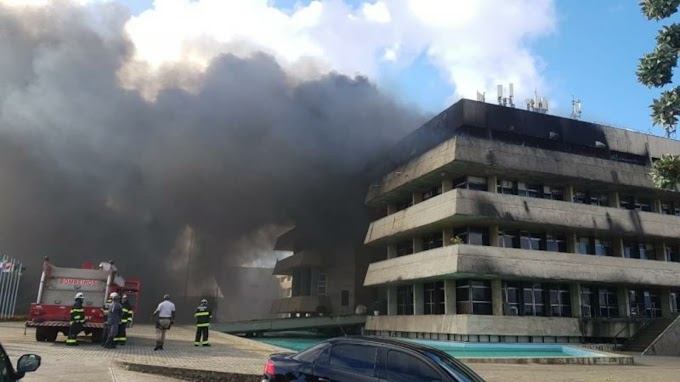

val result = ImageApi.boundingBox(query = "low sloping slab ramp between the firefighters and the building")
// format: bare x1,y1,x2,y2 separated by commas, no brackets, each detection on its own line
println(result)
215,316,366,334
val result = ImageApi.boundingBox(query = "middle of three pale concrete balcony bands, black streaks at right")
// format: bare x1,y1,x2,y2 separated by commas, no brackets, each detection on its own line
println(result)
365,189,680,244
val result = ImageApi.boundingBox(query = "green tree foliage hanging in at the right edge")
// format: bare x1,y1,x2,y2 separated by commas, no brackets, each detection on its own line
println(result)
636,0,680,190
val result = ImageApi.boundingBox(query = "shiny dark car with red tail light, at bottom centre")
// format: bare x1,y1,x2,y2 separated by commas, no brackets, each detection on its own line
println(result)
262,337,484,382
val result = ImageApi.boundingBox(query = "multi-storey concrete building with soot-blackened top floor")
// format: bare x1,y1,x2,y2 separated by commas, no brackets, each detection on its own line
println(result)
364,100,680,342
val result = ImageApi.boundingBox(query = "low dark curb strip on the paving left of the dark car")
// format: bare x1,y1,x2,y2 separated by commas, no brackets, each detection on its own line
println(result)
115,361,262,382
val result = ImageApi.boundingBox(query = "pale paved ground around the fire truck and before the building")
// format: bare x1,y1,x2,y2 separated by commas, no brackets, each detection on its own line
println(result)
0,322,680,382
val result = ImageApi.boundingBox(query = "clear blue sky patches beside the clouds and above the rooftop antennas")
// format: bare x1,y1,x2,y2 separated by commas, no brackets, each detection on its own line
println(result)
119,0,664,134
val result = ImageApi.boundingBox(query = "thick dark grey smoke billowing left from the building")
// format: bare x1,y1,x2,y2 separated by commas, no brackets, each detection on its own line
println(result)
0,3,422,314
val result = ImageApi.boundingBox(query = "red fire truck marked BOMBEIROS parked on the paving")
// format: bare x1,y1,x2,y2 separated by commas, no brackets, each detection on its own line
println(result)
26,258,141,342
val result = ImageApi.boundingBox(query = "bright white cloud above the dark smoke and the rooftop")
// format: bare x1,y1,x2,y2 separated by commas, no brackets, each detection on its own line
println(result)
11,0,556,101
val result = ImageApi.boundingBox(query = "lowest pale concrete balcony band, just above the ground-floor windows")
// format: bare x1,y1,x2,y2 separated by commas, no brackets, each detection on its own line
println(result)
364,245,680,287
